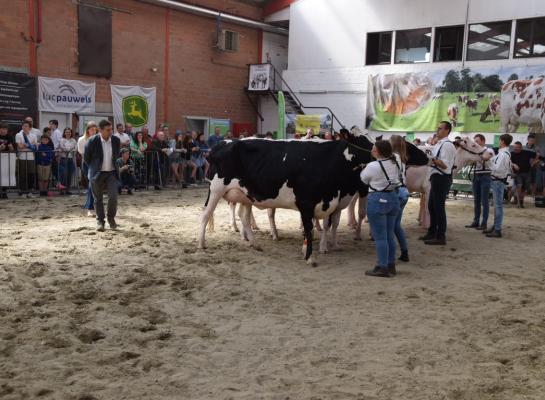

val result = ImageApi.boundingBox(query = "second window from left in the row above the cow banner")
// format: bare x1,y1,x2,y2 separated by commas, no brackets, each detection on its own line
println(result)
395,28,431,63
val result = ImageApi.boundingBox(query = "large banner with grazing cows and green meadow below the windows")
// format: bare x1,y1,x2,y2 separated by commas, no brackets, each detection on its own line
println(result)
367,66,545,132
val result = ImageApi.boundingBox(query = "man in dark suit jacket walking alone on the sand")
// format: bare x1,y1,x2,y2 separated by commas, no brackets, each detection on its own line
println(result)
84,119,121,232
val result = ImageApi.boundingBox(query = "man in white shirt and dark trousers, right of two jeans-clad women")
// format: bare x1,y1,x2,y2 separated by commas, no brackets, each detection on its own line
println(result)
420,121,456,245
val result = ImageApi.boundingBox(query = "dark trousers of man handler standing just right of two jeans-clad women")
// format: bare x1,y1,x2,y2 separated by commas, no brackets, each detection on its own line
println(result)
428,174,452,239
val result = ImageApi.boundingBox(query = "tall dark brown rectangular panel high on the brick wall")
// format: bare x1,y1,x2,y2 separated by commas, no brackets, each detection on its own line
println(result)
78,5,112,78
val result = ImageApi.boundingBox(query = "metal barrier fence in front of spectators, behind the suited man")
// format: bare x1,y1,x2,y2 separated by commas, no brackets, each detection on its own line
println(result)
0,150,205,197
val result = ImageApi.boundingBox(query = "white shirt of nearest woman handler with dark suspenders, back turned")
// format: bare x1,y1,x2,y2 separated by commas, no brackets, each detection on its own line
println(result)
360,154,404,192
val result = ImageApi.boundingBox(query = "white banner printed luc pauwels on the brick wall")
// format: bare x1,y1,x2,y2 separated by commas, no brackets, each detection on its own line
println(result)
38,76,96,113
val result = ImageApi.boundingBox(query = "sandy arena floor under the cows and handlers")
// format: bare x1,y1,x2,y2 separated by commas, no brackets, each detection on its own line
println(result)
0,189,545,400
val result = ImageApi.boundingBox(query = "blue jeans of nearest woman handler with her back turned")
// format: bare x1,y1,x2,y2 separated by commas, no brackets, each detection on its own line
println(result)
367,192,399,268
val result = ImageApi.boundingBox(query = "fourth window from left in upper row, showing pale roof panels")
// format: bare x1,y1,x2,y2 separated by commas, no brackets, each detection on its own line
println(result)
467,21,511,60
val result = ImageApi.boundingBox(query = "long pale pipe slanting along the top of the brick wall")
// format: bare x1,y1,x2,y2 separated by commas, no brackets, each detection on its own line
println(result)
139,0,289,36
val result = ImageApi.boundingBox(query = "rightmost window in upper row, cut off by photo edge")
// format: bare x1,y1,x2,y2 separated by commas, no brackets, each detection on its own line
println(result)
515,18,545,57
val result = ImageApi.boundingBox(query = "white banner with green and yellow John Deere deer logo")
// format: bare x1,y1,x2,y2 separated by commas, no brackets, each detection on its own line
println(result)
110,85,157,134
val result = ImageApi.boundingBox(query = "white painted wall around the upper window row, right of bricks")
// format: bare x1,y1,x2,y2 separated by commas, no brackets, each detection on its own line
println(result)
284,0,545,136
